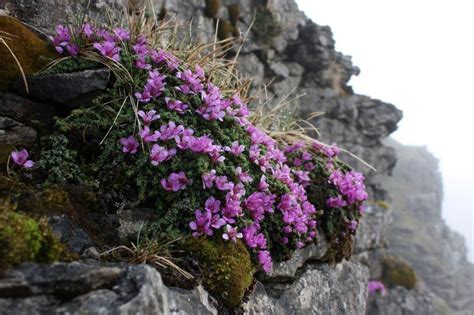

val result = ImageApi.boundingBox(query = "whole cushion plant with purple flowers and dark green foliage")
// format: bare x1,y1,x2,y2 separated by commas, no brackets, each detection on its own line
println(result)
39,16,367,272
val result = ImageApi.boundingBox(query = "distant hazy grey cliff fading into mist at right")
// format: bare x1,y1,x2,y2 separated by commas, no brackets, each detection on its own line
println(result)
386,141,474,314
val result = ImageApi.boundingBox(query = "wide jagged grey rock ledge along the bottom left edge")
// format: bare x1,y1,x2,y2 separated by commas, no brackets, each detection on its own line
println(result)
0,263,217,315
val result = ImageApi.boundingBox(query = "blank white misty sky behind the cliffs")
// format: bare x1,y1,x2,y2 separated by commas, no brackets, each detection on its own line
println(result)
296,0,474,262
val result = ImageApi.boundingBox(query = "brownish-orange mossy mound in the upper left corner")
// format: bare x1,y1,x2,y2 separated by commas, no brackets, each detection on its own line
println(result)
0,16,57,91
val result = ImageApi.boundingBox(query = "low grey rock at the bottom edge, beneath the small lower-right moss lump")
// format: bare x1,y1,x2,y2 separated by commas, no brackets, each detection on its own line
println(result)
366,287,436,315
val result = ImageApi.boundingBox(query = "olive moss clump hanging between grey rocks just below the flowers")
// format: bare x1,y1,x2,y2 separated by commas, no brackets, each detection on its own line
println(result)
184,238,255,309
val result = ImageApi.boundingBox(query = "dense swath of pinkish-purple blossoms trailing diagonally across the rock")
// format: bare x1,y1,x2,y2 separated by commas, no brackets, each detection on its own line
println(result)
53,23,367,272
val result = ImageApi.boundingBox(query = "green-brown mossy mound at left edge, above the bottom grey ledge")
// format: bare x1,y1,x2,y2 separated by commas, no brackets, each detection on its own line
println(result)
0,201,64,270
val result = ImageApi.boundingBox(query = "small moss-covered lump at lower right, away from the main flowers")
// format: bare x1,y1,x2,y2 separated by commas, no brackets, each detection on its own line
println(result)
382,256,417,289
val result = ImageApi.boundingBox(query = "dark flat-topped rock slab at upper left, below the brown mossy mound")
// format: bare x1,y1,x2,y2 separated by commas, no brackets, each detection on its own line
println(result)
16,69,110,107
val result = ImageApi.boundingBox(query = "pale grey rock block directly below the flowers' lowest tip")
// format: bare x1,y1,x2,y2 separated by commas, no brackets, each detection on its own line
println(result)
243,261,368,314
